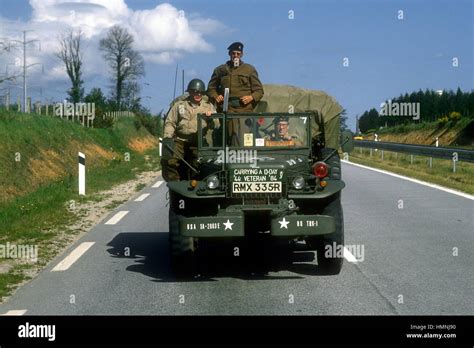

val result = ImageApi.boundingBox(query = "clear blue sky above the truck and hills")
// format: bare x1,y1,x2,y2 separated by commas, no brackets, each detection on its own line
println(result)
0,0,474,128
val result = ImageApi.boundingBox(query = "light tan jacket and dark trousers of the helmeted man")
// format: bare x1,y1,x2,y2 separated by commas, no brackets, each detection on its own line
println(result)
161,99,215,181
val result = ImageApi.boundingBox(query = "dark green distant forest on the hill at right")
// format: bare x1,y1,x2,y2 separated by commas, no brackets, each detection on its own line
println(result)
359,88,474,133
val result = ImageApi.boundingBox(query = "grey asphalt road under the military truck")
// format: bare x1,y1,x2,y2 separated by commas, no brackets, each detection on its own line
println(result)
0,164,474,315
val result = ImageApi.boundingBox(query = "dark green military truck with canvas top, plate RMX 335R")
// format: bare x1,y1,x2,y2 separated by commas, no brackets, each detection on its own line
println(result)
168,85,353,275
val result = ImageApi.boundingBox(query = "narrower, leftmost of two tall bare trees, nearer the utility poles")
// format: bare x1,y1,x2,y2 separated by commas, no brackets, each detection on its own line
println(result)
56,30,84,103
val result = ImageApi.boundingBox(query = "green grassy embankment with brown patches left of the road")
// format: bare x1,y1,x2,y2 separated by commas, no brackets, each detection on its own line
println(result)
0,110,159,299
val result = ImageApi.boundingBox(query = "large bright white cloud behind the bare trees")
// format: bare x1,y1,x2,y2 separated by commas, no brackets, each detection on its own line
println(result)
0,0,226,85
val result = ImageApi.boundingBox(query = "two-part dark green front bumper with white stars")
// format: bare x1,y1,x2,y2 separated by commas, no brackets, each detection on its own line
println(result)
179,213,336,238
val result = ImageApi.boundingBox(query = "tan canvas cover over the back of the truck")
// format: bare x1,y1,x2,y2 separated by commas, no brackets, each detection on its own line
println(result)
255,84,343,149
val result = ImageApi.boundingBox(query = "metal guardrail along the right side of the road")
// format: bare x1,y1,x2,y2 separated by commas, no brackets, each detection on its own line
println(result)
354,140,474,162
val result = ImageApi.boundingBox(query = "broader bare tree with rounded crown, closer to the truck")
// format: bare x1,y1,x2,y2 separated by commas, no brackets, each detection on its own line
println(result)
100,25,145,109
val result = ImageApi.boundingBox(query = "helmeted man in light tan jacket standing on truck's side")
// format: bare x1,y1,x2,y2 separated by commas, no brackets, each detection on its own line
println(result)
161,79,215,181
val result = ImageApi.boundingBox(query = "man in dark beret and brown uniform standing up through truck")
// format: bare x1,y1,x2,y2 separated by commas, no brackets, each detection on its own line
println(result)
207,42,263,145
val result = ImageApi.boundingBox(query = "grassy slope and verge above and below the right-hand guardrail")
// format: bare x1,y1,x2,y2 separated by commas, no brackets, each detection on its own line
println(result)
350,119,474,194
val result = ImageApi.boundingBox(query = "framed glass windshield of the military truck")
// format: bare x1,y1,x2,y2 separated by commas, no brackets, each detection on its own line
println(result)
199,113,310,149
